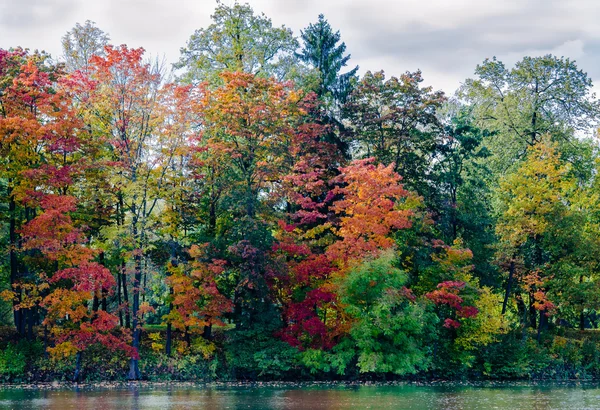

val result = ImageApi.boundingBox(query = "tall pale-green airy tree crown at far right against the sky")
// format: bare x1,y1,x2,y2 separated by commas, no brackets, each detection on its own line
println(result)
461,55,600,173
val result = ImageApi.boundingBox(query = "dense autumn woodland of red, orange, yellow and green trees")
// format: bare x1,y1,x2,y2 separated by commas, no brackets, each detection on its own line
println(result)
0,3,600,381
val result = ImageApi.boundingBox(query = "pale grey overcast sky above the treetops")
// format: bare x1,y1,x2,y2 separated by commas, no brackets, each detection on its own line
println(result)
0,0,600,93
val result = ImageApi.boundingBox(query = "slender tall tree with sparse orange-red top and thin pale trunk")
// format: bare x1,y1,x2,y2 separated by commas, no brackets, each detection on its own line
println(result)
72,46,192,379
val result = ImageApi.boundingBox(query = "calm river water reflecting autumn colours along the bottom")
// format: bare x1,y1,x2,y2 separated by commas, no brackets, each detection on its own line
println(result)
0,384,600,410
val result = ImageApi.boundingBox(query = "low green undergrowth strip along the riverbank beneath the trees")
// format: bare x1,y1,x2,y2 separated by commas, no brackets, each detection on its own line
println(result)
0,326,600,382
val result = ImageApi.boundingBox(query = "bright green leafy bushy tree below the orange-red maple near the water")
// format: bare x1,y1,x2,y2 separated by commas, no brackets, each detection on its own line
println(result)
340,252,434,375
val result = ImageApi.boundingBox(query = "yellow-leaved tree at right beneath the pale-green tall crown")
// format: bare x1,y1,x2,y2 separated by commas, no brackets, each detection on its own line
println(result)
496,137,581,330
